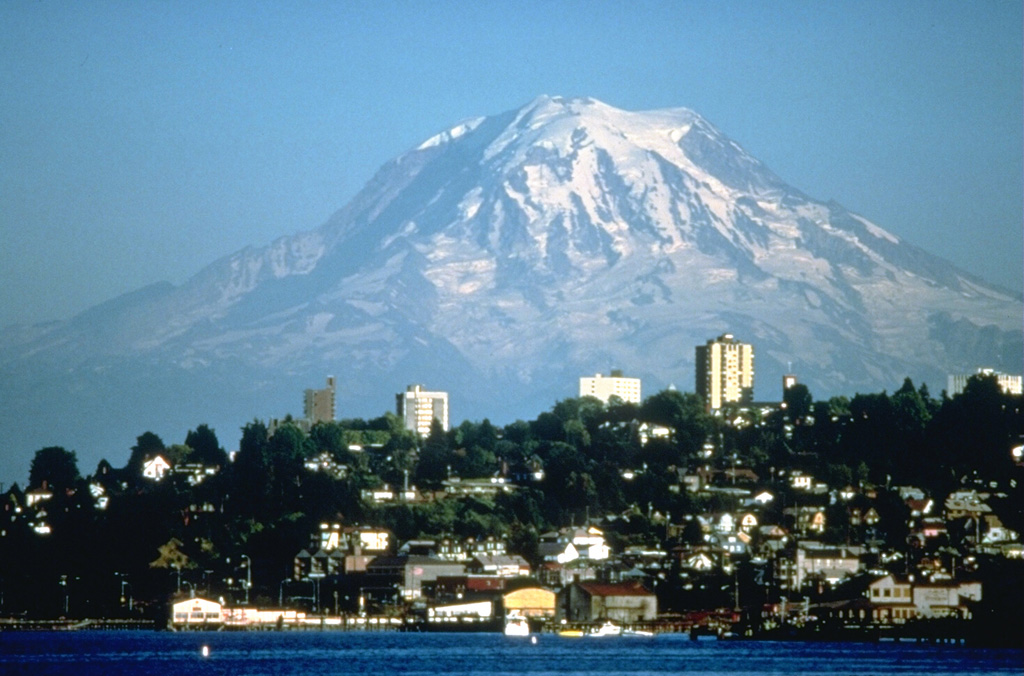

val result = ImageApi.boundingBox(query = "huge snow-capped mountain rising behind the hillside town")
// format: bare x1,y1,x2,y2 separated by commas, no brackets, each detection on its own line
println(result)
0,96,1024,481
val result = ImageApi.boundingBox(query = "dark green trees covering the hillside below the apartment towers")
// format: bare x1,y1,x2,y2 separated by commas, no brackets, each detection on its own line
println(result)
0,378,1024,615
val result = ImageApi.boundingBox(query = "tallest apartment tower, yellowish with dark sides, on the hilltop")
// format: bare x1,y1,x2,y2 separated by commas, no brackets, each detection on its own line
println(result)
696,333,754,411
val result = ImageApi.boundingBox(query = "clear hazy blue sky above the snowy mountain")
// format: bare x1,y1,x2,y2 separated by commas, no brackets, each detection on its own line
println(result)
0,0,1024,326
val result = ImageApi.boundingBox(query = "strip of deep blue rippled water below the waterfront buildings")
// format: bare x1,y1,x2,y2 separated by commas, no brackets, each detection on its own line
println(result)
0,631,1024,676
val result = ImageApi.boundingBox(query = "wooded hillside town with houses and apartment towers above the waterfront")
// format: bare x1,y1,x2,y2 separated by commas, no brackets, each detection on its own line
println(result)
0,358,1024,641
